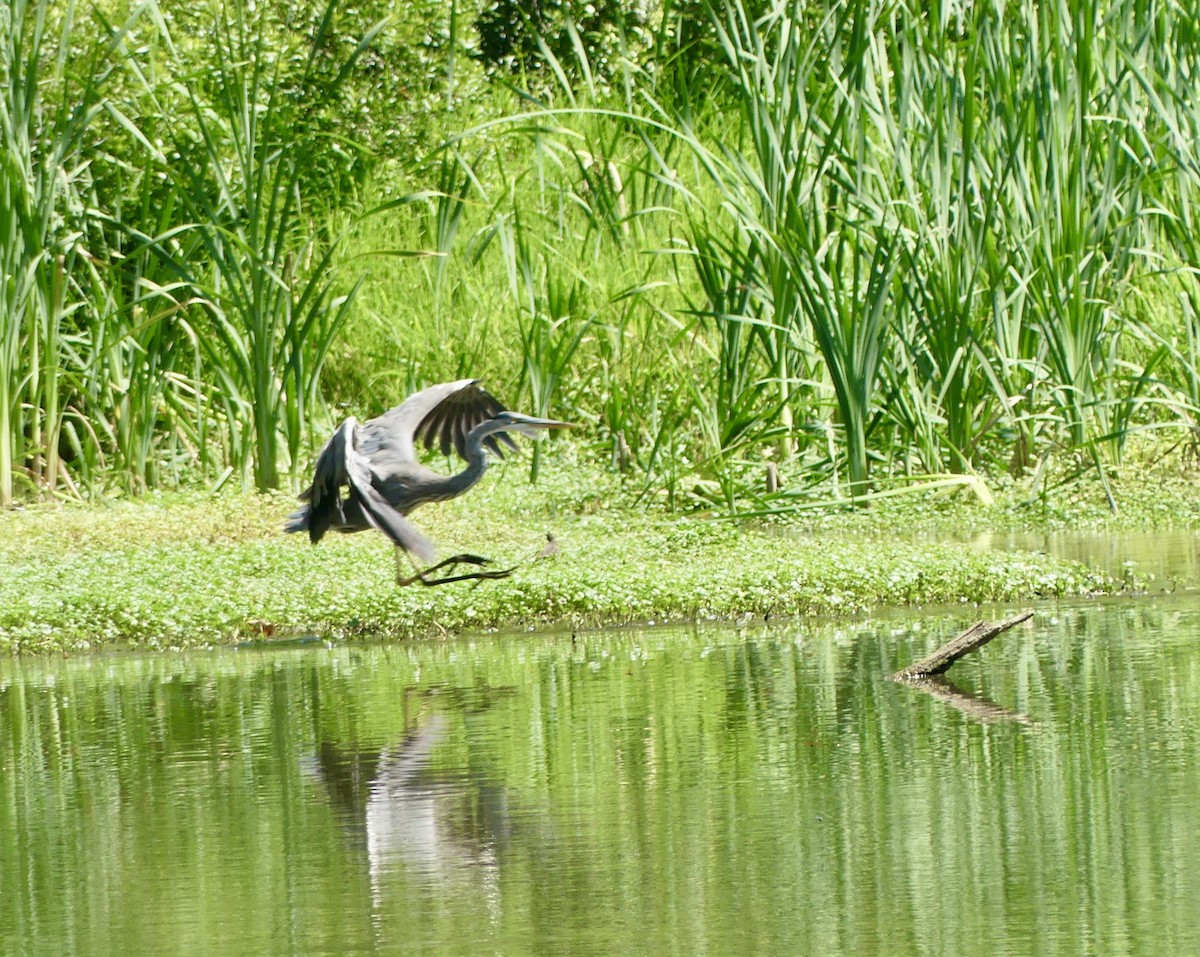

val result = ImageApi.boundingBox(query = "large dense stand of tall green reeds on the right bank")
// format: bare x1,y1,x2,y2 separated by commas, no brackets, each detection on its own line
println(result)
657,0,1162,490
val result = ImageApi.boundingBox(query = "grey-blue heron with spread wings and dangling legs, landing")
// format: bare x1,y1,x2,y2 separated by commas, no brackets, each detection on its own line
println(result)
284,379,571,585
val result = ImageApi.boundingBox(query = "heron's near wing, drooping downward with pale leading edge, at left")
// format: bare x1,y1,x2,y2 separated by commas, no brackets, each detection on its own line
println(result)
302,419,437,561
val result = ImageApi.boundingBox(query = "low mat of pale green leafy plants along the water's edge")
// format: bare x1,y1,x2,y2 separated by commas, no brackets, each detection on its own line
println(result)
0,450,1166,651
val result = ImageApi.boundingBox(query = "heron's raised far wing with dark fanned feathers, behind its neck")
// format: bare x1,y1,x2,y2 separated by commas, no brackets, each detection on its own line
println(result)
359,379,517,462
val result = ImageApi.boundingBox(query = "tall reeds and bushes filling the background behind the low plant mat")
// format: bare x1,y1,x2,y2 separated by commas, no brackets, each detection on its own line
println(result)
7,0,1200,512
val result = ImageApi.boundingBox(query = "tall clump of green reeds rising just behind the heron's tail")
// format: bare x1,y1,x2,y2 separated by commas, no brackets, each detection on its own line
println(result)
142,0,380,489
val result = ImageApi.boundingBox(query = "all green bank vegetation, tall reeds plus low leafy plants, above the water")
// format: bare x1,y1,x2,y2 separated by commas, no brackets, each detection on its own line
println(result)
7,0,1200,650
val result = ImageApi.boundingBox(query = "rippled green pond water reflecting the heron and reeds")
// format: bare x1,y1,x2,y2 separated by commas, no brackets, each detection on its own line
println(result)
0,591,1200,957
